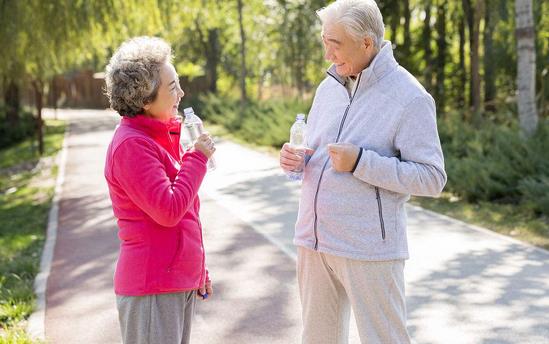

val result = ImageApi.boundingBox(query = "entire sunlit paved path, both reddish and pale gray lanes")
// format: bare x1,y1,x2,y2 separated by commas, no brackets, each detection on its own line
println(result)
40,111,549,344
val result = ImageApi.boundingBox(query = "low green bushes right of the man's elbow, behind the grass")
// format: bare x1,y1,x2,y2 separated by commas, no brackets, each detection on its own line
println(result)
439,115,549,215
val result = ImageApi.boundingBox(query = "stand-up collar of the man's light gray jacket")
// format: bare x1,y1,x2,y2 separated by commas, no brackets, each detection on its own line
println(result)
326,40,398,88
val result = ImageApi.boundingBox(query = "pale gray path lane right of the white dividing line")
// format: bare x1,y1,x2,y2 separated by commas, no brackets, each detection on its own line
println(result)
200,142,549,344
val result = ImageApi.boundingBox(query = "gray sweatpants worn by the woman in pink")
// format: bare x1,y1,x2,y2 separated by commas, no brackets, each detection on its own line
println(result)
116,291,196,344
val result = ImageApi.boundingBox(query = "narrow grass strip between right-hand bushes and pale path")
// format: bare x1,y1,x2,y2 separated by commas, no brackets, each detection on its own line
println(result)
411,193,549,250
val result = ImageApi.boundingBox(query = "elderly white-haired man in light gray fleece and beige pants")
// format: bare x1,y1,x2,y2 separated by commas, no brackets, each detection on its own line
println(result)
280,0,446,344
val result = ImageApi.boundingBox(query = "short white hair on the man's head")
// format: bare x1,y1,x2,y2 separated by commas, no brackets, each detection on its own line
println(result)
316,0,385,50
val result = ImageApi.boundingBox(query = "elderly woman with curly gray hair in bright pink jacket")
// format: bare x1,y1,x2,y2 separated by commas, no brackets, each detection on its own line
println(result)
105,37,215,344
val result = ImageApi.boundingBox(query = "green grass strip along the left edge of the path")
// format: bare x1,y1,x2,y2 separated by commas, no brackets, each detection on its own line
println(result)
0,121,65,343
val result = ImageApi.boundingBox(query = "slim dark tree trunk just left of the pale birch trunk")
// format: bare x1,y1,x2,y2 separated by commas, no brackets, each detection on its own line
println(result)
484,0,496,112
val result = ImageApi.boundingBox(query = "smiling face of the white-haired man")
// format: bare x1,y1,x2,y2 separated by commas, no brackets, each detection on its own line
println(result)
322,24,376,77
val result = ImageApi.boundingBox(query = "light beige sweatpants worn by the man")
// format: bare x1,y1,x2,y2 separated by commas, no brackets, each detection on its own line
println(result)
297,247,410,344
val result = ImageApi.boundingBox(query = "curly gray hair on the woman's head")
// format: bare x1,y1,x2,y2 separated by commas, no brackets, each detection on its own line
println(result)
105,36,172,117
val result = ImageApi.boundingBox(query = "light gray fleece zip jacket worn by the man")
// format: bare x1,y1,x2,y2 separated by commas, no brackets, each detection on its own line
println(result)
294,41,446,261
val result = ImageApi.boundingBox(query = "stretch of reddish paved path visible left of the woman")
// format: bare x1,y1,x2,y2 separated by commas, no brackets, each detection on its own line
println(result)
45,111,120,344
